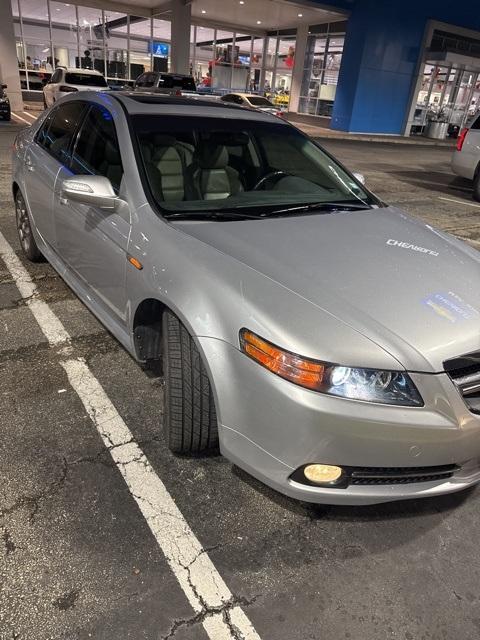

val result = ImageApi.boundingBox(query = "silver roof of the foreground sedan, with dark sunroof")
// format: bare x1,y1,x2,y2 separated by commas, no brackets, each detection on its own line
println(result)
69,91,291,126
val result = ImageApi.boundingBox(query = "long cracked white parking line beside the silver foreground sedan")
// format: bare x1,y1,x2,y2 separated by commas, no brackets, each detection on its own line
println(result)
0,232,260,640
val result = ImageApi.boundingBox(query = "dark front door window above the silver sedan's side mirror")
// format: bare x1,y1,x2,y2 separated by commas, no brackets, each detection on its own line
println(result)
71,105,123,192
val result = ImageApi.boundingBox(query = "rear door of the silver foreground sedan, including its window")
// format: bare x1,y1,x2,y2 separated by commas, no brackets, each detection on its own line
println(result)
23,102,86,249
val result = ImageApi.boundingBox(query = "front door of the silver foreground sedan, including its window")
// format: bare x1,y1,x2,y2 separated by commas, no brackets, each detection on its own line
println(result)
54,104,130,325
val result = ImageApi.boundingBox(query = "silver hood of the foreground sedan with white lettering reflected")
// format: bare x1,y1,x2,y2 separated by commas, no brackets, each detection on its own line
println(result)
175,207,480,373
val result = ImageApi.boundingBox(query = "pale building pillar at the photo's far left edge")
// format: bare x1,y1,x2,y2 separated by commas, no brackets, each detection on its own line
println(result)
0,0,23,111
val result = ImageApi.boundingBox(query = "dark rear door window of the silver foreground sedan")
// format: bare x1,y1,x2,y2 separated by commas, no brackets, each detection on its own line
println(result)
37,102,85,164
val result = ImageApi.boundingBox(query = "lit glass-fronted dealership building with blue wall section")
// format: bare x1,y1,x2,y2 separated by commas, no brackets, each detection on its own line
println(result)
0,0,480,135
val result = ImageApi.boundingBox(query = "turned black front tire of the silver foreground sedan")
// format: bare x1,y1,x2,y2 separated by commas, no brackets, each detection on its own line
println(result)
162,311,218,454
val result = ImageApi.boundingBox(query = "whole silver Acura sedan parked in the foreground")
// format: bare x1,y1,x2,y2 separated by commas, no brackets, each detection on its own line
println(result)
13,92,480,504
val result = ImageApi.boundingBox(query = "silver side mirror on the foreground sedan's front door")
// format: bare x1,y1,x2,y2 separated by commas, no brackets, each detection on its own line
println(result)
61,175,121,211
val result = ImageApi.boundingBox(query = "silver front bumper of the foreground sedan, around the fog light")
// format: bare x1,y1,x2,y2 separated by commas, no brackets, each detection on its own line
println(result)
198,338,480,504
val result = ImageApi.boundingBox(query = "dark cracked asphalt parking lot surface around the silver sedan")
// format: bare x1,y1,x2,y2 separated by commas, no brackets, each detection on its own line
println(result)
0,125,480,640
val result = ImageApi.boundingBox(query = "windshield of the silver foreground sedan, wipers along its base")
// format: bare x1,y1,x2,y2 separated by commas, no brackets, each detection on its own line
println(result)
132,115,378,220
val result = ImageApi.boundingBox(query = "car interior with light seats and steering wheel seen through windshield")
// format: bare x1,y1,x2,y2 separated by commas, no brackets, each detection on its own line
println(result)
138,129,364,208
